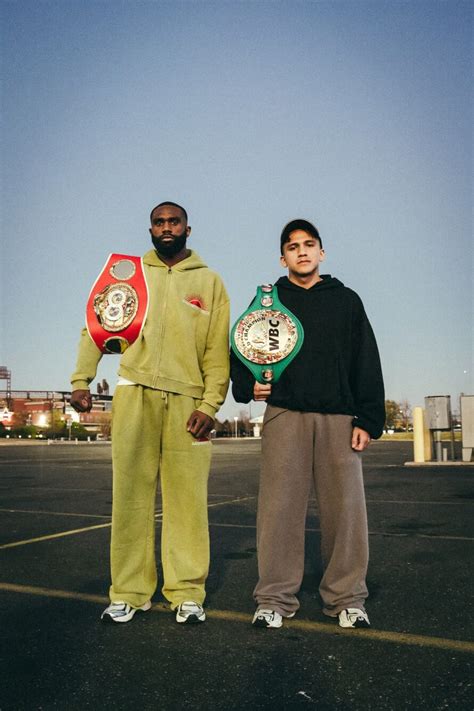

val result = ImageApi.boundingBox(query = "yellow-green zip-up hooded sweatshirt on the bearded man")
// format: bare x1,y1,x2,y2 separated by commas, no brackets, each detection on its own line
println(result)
71,249,229,417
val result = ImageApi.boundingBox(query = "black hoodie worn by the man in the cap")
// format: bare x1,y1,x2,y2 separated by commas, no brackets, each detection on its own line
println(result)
231,274,385,439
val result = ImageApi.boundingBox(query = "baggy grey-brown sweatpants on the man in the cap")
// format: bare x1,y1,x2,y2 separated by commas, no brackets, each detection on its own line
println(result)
254,405,369,617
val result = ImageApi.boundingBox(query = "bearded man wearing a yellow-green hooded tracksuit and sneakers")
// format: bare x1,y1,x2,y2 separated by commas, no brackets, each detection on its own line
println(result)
71,202,229,623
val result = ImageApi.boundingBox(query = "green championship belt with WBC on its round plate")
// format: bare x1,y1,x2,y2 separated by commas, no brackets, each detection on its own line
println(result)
230,284,304,383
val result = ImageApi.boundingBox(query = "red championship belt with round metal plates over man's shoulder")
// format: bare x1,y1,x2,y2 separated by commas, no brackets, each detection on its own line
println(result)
86,254,148,353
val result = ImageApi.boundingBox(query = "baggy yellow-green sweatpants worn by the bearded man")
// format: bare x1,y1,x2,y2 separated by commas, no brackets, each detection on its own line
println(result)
110,385,212,608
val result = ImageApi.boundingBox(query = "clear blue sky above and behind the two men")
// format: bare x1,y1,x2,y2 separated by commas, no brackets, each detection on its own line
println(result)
0,0,474,417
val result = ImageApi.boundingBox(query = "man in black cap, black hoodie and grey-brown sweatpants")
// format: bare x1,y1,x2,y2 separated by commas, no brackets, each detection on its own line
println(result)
231,219,385,627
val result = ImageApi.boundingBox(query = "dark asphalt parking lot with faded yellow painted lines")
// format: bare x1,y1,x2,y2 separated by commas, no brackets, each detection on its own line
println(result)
0,439,474,711
